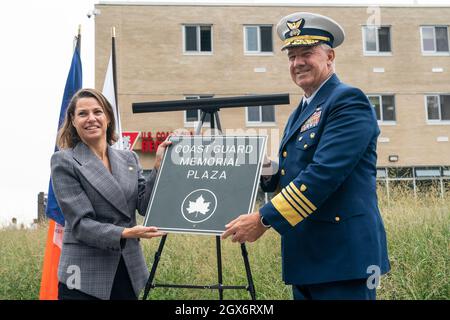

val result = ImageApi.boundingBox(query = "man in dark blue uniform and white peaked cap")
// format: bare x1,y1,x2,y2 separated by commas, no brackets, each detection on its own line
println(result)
222,12,390,299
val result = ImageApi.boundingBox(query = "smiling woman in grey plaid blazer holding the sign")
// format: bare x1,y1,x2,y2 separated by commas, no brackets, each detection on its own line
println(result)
51,89,170,300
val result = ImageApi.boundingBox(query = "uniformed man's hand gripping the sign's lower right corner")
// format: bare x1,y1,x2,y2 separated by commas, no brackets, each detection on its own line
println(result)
222,211,268,243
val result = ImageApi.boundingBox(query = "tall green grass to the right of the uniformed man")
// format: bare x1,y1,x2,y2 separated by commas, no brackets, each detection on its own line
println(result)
379,188,450,300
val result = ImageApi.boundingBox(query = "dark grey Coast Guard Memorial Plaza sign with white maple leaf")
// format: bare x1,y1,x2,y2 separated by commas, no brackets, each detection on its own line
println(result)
144,136,266,235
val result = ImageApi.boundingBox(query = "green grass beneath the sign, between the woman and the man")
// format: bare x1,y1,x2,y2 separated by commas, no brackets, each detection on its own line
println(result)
139,231,291,299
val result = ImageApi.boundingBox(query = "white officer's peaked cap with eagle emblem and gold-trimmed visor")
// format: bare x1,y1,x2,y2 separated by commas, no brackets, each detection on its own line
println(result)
277,12,345,50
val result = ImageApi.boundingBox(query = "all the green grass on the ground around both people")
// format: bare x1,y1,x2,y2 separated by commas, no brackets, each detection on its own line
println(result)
0,191,450,300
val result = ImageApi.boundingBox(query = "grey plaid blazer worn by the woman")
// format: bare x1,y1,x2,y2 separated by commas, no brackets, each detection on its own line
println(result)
51,142,156,299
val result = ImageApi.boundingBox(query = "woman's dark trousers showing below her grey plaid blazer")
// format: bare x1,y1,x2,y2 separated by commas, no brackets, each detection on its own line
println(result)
58,257,137,300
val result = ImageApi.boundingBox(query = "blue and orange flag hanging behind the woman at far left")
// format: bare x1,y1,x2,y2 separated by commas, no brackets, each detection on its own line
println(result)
39,32,83,300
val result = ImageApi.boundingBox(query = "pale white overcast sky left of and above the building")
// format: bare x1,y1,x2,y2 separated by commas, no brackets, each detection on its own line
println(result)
0,0,450,227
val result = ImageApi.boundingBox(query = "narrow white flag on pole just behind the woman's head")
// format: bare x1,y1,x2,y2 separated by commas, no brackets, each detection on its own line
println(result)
102,28,125,150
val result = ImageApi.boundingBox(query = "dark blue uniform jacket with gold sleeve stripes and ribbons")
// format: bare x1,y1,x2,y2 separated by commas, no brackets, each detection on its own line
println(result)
260,75,389,285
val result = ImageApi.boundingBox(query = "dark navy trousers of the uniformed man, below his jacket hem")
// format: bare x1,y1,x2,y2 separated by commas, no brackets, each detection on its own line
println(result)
292,279,376,300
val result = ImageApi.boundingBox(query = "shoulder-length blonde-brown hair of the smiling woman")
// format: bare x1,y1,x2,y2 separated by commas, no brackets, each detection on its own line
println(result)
56,89,117,149
